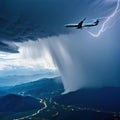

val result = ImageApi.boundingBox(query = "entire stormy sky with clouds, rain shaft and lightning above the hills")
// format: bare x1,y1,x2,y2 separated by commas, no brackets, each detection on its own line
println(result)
0,0,120,92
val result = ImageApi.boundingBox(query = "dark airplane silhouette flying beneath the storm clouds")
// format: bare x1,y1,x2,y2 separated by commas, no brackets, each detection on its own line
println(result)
65,18,99,29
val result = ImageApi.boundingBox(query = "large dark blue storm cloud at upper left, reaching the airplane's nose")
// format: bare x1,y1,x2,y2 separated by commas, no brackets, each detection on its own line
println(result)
0,0,112,52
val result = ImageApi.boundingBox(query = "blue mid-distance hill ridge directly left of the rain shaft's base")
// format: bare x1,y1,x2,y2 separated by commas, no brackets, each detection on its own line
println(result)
7,77,64,98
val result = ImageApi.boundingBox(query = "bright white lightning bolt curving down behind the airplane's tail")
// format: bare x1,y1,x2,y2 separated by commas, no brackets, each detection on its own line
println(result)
88,0,120,37
